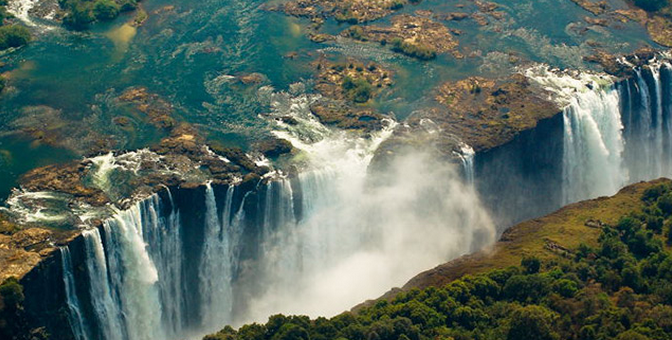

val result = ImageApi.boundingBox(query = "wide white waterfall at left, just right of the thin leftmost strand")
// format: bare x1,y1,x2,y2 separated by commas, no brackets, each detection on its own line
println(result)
74,198,170,340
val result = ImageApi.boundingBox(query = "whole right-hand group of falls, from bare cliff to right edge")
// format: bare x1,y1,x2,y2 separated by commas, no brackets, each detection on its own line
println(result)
528,61,672,204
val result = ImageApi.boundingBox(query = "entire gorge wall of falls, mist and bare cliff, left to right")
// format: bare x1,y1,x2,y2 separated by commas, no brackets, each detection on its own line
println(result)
9,55,672,339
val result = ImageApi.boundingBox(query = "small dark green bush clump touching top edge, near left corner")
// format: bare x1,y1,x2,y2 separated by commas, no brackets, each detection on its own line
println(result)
59,0,138,30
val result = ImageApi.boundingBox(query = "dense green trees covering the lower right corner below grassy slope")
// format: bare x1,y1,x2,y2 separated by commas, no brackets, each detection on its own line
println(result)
204,182,672,340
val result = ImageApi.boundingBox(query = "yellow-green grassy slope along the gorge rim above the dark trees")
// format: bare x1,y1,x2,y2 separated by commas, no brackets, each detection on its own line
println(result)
400,179,672,297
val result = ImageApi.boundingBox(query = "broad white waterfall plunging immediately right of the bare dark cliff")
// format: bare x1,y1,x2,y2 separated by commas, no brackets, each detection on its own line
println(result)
528,67,628,204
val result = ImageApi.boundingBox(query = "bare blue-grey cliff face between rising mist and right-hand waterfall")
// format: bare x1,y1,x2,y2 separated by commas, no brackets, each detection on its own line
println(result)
474,113,564,232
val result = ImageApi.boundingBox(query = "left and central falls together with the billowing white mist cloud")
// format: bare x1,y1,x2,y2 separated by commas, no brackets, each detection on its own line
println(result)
60,85,495,339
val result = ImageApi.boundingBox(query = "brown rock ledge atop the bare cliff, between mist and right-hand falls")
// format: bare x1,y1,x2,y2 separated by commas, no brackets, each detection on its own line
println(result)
373,74,562,169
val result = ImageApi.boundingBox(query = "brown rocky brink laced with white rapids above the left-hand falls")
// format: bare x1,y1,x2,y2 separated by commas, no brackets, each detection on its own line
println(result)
0,124,292,282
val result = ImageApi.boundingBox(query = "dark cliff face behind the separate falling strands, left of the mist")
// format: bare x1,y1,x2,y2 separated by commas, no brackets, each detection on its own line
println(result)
10,180,301,339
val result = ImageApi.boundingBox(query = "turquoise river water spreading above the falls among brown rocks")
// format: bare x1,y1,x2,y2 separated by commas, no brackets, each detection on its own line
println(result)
0,0,650,197
